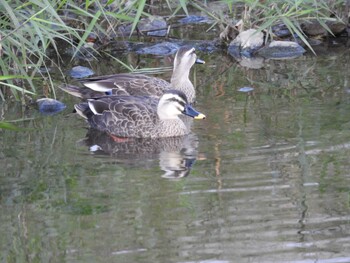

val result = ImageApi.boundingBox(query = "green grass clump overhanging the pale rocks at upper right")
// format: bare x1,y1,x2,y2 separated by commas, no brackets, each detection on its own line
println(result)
191,0,344,50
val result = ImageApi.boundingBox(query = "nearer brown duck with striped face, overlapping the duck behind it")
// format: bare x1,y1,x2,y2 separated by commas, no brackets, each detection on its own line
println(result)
74,90,205,138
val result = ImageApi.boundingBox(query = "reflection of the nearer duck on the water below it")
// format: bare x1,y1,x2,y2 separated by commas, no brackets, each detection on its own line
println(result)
81,129,198,179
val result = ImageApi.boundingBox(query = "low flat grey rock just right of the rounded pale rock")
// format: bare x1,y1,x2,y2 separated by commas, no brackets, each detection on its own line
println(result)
258,41,305,59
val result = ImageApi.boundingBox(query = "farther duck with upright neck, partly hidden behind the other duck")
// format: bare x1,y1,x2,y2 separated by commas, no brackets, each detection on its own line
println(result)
61,46,205,104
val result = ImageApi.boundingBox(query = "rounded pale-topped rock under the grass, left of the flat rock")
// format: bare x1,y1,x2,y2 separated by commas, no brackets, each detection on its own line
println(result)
229,29,264,57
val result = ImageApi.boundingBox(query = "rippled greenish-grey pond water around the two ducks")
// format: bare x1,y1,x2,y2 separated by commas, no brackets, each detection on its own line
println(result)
0,42,350,263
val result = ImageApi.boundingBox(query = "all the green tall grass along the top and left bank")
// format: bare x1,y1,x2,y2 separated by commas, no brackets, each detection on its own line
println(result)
0,0,343,100
